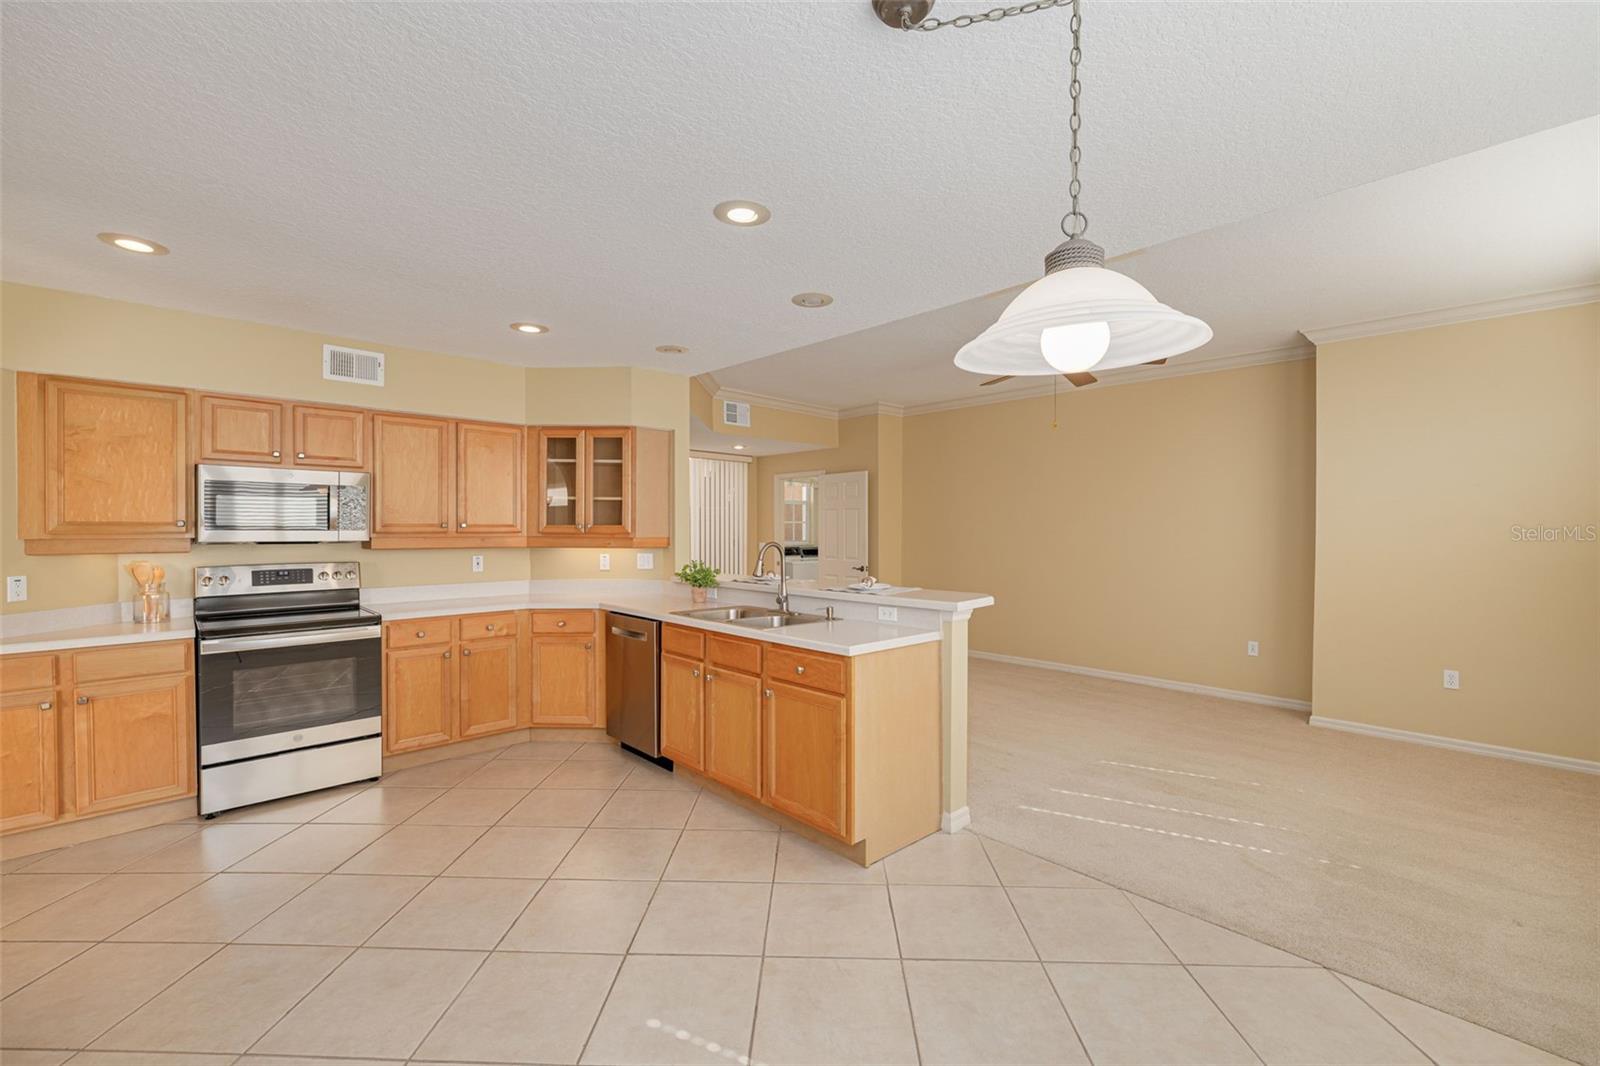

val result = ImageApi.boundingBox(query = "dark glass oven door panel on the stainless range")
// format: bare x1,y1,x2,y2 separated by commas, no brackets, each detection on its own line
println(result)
198,637,382,747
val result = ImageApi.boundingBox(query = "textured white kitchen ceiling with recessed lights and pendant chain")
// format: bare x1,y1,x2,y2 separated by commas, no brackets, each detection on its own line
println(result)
0,0,1600,373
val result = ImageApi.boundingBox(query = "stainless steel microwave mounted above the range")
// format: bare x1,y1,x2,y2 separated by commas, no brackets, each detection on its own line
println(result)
195,464,373,544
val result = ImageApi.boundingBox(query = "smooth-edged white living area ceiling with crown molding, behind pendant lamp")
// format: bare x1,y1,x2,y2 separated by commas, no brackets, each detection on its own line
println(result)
717,118,1600,408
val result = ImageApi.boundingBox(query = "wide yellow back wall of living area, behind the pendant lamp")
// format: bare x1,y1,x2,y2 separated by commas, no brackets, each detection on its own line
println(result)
902,360,1315,699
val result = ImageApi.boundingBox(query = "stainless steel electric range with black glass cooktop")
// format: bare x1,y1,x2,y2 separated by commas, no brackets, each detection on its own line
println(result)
195,562,384,818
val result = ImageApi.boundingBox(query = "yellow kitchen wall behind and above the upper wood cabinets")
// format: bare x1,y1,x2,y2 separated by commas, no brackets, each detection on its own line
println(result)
0,283,688,613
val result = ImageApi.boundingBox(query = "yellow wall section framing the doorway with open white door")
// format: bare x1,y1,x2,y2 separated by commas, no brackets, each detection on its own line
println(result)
750,415,904,581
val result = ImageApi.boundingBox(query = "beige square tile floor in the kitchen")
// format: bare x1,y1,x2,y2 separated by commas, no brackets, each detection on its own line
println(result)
0,741,1562,1066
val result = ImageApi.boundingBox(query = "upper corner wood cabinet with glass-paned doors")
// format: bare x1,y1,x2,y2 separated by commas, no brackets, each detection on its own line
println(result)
528,426,672,547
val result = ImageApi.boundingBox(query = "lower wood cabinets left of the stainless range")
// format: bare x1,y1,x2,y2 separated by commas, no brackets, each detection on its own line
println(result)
0,640,195,832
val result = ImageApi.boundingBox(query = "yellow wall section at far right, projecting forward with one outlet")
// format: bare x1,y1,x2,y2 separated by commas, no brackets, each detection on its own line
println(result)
1312,304,1600,759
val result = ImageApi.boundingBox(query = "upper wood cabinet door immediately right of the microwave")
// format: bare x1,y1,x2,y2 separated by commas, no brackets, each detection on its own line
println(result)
373,415,456,539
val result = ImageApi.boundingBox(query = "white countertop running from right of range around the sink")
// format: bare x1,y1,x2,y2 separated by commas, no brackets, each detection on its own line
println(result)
371,589,939,655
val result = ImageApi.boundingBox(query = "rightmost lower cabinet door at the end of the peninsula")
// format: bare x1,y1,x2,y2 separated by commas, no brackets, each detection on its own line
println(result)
762,681,850,839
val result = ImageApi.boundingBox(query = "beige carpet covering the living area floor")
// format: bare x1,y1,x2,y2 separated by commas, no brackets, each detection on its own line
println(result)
971,659,1600,1064
